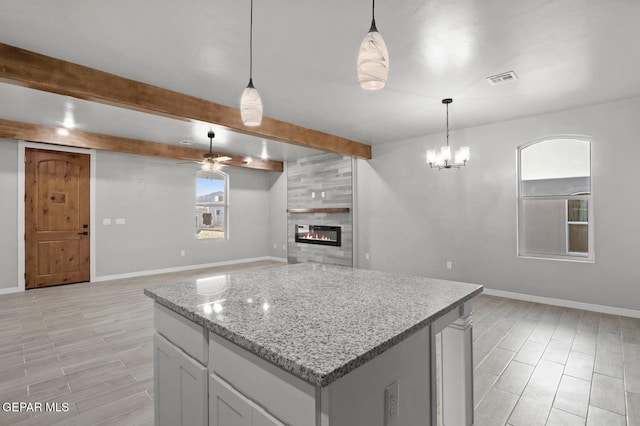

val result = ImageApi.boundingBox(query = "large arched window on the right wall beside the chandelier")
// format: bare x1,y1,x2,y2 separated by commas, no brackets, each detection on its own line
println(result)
518,138,593,261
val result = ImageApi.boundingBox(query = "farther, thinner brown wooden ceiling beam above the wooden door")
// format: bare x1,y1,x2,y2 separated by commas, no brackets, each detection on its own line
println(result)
0,119,283,172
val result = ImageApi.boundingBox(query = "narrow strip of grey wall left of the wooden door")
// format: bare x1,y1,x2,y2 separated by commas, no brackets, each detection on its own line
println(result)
0,139,18,290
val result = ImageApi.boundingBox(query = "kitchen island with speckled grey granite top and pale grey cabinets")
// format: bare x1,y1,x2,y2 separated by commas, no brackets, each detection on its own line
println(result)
145,263,482,426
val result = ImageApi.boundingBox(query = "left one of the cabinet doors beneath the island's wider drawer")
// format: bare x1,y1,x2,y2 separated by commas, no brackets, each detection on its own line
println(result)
209,374,253,426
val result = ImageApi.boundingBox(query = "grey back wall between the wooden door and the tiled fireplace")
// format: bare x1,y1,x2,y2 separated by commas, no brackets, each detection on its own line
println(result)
93,152,274,278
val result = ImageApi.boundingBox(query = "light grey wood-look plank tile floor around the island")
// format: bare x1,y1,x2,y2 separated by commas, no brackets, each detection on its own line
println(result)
0,262,640,426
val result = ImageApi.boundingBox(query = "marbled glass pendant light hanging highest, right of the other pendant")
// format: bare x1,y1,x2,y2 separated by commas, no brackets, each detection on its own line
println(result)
358,0,389,90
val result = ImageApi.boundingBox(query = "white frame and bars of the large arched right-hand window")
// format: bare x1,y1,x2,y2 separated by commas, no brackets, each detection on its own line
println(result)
516,135,595,263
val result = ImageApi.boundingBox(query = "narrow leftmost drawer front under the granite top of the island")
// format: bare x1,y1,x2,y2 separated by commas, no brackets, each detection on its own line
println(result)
153,303,209,365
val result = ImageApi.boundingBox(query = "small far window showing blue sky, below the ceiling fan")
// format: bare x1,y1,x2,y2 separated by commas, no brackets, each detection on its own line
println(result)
196,171,229,240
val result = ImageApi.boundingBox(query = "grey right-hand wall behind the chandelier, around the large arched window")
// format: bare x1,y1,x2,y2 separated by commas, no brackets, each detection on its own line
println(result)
358,98,640,310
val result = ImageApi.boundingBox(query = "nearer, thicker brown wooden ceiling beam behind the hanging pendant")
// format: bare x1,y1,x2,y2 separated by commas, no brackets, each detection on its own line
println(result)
0,43,371,159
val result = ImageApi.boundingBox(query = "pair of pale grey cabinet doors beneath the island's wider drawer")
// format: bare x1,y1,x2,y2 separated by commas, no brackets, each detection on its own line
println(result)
209,374,285,426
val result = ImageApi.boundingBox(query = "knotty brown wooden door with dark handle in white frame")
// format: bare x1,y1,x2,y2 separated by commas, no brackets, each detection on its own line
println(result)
25,148,90,289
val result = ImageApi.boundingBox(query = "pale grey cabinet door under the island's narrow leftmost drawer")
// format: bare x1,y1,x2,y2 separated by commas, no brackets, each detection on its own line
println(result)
153,333,208,426
